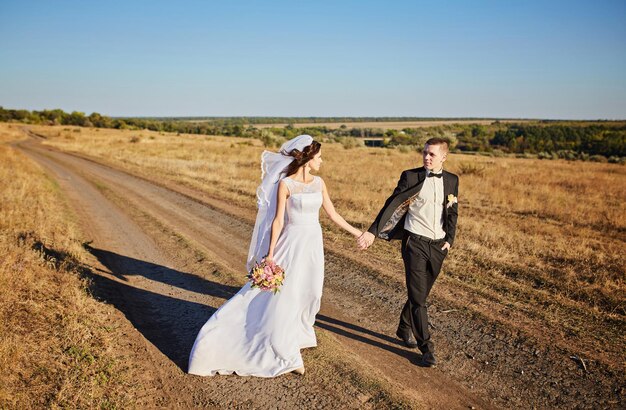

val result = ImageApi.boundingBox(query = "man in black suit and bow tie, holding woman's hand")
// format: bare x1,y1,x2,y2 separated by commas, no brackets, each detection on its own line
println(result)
357,138,459,367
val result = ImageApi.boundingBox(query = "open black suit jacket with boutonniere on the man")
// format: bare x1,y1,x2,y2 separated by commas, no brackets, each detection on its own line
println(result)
368,167,459,246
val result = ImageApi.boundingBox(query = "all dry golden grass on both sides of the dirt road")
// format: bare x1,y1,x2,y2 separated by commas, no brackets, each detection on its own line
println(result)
0,124,626,407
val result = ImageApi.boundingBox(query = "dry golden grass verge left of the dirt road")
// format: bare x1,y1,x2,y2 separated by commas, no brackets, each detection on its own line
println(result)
0,126,127,408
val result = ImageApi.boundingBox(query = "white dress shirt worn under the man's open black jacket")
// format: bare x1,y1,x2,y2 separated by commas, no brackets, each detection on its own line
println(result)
404,169,446,239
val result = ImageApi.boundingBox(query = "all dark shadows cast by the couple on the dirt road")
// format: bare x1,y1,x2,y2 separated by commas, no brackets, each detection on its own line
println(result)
79,245,418,371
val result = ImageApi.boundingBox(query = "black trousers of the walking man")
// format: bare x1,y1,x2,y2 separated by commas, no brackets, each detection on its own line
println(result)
398,231,448,353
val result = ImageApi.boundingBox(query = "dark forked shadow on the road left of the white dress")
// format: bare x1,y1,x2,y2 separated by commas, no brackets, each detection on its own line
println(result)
84,246,239,371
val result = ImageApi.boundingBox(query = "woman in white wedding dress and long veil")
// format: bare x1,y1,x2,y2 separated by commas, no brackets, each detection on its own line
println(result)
189,135,361,377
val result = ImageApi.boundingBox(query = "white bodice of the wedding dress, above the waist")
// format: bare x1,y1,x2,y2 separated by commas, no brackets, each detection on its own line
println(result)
283,176,322,224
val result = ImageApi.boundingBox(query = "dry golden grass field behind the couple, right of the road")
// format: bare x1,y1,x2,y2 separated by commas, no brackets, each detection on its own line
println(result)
33,121,626,370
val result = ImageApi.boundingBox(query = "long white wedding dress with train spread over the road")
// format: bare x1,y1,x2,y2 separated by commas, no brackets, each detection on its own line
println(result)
189,176,324,377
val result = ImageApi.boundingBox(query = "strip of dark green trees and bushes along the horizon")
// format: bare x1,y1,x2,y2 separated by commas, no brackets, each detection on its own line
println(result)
0,107,626,163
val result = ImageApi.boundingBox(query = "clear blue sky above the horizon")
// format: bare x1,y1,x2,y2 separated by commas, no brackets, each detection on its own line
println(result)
0,0,626,119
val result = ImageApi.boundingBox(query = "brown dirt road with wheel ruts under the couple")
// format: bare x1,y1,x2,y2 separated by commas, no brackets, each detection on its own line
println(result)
17,133,619,408
